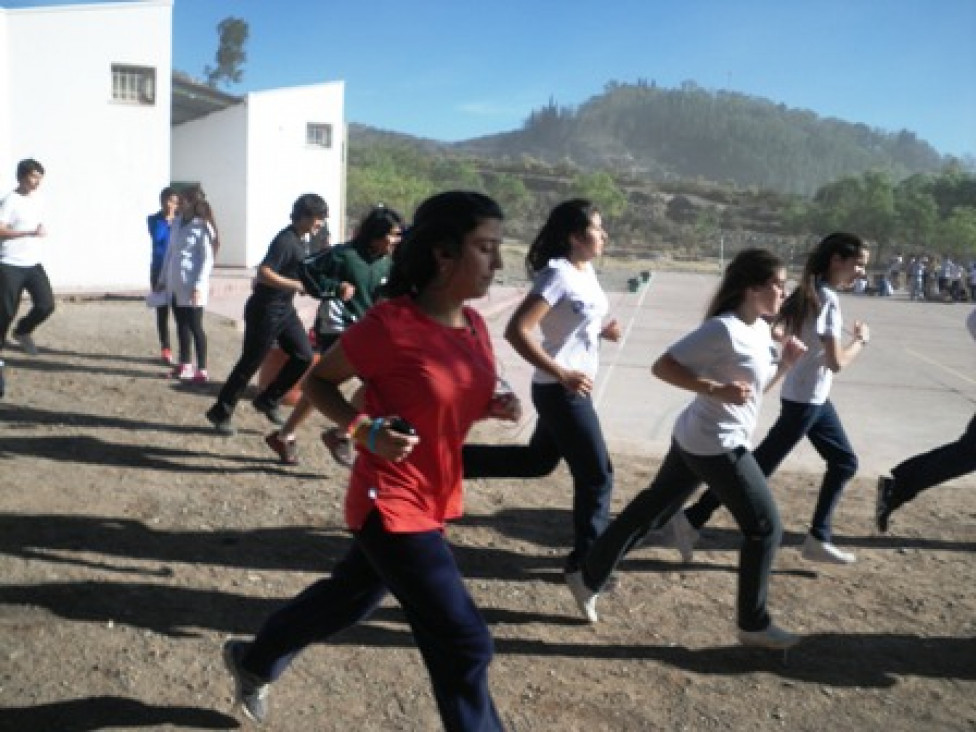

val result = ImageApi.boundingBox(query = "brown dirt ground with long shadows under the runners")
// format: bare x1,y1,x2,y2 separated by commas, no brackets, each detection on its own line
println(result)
0,299,976,732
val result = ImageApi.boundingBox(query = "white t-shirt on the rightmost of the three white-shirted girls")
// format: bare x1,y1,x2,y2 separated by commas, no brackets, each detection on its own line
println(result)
780,284,844,404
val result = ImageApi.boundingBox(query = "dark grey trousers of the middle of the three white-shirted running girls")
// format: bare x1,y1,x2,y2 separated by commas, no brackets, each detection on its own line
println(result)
581,441,783,631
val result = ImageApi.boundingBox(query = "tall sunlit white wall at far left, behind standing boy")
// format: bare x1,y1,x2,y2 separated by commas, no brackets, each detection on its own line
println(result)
0,0,173,292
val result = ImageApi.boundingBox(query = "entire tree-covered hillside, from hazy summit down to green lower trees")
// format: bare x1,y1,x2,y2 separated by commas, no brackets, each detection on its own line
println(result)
347,83,976,261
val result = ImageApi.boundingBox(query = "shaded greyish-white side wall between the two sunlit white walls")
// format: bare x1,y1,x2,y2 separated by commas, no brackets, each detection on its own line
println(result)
171,104,244,267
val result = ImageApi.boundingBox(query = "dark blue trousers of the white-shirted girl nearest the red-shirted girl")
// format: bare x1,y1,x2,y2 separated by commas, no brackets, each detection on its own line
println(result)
462,384,613,571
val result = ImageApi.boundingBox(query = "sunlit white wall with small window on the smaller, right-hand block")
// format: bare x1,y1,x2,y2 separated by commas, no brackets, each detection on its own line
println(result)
245,81,345,267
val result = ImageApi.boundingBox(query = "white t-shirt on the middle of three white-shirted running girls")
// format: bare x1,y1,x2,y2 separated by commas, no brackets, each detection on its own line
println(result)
668,313,779,455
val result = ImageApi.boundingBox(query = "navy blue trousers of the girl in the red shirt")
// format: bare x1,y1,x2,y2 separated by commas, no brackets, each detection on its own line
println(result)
242,511,503,732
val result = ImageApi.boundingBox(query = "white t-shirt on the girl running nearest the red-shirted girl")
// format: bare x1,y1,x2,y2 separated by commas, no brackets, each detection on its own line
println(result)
529,259,610,384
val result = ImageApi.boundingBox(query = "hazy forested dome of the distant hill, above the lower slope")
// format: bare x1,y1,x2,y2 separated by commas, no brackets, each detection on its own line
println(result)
453,82,947,195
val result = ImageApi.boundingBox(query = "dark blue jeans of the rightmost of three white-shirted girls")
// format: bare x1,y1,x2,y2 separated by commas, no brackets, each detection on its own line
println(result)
685,399,857,541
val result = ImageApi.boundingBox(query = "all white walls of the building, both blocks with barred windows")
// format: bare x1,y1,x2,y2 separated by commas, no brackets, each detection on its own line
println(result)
0,0,346,284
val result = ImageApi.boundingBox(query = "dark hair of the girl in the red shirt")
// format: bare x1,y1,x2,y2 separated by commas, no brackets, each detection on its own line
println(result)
386,191,505,297
